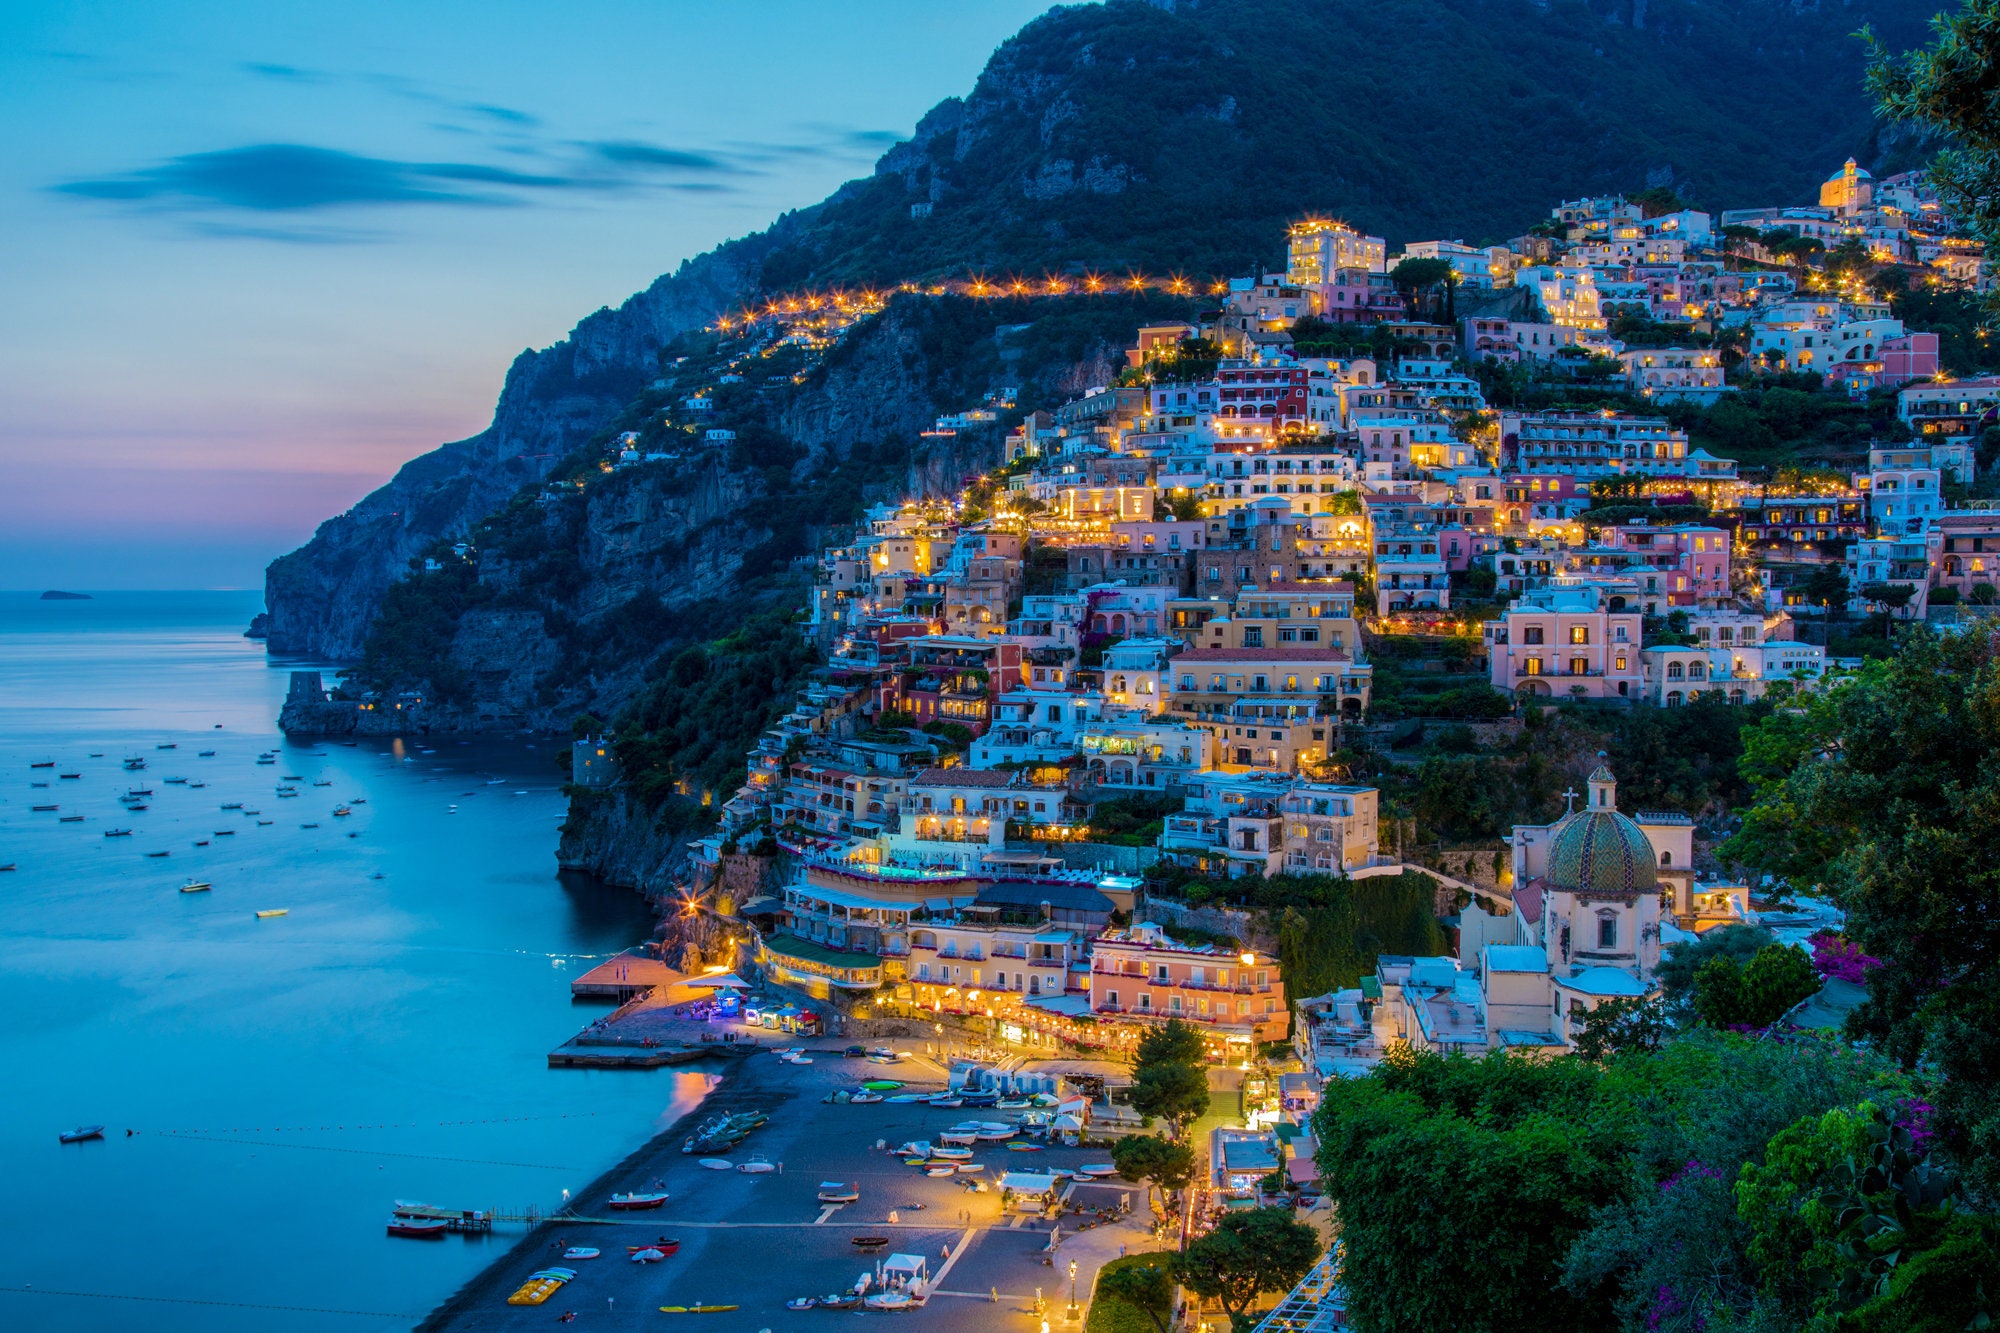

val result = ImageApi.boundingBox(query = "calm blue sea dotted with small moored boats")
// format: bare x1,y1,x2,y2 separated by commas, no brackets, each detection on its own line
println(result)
0,592,706,1333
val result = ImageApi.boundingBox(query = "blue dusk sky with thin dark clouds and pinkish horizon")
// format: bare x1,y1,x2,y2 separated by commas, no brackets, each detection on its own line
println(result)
0,0,1046,590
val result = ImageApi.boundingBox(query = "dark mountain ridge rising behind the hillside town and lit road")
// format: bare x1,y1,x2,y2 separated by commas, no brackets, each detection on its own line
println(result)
266,0,1930,660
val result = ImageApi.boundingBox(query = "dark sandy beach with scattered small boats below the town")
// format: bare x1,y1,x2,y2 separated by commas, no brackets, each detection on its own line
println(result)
420,1039,1152,1333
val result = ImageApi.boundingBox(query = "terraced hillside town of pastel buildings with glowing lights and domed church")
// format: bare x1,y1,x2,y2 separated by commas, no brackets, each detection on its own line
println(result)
576,162,2000,1069
